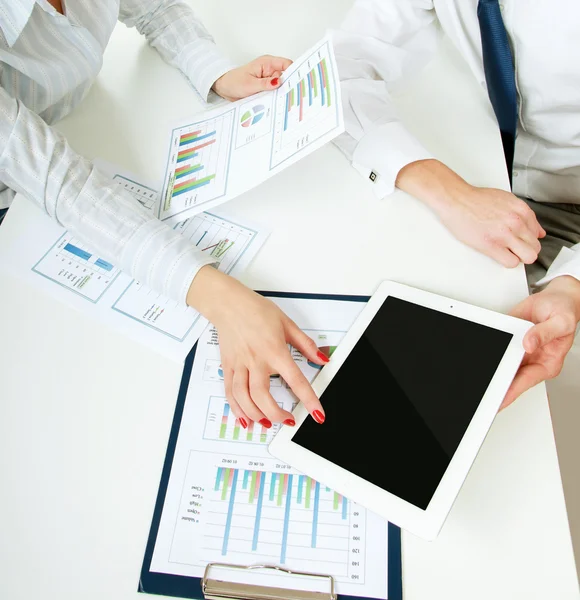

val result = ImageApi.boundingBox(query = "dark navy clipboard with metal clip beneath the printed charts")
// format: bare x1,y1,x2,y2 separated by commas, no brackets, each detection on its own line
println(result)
138,292,403,600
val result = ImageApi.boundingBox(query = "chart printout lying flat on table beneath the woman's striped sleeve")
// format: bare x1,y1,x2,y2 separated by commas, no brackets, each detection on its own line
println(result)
0,161,267,360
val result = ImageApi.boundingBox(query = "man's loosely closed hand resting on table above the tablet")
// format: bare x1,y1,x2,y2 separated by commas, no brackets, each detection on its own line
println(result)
396,160,546,268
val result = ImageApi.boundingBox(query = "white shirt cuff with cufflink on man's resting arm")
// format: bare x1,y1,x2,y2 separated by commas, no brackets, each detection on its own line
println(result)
352,121,434,198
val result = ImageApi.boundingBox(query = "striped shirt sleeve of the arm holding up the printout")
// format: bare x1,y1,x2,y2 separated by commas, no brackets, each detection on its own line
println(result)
119,0,236,101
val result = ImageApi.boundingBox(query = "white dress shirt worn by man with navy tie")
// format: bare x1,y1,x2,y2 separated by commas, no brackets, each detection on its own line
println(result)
334,0,580,285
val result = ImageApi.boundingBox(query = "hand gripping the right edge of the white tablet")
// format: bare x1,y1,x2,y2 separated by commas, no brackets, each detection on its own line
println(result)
501,276,580,408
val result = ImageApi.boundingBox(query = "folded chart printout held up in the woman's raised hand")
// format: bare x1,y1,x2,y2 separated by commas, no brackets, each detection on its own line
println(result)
158,38,344,223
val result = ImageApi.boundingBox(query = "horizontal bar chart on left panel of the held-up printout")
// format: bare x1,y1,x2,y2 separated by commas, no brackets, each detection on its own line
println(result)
160,111,235,219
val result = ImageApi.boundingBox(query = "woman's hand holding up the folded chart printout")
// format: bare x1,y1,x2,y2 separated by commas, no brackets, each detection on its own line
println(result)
213,56,292,101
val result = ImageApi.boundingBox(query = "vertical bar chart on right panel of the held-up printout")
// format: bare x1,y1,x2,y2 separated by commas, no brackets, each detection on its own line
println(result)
270,42,339,169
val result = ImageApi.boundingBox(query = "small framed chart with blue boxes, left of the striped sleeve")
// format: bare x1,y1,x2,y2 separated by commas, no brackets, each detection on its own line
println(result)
32,233,119,303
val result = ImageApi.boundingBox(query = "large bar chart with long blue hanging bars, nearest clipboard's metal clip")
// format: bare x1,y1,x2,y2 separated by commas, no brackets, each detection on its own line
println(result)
171,455,366,583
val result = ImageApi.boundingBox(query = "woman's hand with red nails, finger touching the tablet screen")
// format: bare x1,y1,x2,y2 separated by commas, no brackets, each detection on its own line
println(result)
188,266,328,428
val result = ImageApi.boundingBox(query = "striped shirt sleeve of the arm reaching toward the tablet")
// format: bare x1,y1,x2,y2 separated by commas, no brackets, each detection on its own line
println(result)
0,87,215,304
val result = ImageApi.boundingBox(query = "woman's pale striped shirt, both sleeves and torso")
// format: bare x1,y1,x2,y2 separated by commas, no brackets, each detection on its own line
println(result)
0,0,233,302
